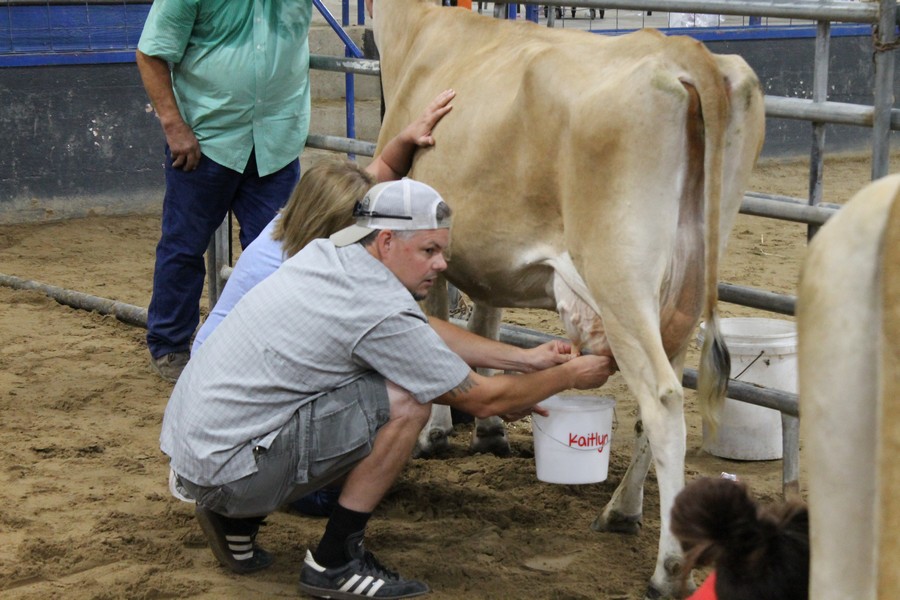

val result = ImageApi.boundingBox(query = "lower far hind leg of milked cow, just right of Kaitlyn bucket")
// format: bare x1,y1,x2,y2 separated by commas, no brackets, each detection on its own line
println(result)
591,419,652,534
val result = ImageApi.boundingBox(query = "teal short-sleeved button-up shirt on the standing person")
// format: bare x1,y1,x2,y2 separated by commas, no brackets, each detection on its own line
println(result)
138,0,312,176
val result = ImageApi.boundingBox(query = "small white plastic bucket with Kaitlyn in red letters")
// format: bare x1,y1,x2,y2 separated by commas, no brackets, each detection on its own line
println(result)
532,395,616,483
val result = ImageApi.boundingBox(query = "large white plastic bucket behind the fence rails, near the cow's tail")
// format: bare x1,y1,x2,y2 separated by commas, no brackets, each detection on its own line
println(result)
698,318,797,460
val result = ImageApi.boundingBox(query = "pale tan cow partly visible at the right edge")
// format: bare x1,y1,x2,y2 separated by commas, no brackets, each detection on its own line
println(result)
797,175,900,600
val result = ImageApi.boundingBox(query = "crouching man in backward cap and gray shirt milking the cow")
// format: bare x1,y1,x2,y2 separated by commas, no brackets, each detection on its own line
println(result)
161,179,612,598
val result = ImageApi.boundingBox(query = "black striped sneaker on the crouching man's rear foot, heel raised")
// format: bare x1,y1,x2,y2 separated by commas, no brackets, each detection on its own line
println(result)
194,506,273,573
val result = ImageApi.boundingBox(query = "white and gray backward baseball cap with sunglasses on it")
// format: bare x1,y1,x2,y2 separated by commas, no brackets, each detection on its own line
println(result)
330,179,450,246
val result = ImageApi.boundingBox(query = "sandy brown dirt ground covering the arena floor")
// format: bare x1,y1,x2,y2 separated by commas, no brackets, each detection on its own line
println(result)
0,157,896,600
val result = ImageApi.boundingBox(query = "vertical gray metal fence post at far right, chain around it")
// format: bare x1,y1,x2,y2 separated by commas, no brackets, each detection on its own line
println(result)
872,0,897,179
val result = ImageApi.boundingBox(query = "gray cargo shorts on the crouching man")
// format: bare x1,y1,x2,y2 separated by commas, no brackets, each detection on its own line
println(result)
180,373,391,517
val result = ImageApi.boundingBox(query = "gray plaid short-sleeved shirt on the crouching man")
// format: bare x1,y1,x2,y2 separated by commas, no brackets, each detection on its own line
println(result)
160,240,470,486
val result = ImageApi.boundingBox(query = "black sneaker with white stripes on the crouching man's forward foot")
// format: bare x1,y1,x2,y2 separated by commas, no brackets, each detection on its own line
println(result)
300,533,430,600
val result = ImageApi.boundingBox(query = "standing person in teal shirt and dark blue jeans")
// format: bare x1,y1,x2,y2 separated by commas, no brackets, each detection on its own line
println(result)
136,0,312,381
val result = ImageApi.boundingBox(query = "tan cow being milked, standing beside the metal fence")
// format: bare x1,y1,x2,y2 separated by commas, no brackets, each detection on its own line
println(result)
374,0,764,597
